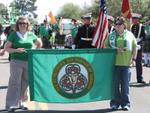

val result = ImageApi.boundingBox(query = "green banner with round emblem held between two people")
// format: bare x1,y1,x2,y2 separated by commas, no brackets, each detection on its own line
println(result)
28,49,115,103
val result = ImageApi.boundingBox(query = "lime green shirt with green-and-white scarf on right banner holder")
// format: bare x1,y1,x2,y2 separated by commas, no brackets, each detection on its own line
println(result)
105,30,137,66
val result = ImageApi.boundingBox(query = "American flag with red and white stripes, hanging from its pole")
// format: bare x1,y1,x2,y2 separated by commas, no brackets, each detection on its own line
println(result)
92,0,108,48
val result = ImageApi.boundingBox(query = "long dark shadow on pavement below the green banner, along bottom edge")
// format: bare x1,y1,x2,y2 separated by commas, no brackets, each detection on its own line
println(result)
0,109,113,113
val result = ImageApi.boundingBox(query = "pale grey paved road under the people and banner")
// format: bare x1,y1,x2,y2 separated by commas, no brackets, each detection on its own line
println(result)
0,54,150,113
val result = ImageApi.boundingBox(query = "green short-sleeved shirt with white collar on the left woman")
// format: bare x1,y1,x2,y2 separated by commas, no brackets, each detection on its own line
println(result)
7,32,37,61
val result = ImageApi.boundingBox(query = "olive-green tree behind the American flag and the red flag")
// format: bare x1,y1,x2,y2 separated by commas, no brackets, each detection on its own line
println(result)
88,0,150,18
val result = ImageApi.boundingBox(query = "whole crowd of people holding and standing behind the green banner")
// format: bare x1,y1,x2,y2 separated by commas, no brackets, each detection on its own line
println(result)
0,14,150,112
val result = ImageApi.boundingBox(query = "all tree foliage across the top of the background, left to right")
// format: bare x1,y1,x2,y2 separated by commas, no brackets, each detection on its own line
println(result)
0,0,150,25
